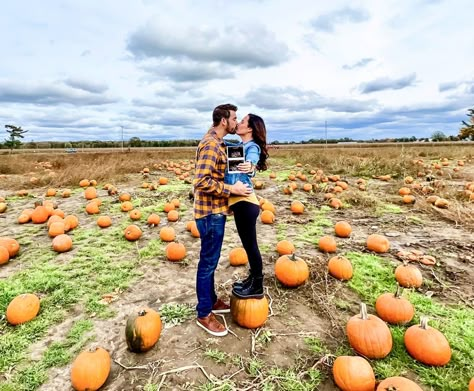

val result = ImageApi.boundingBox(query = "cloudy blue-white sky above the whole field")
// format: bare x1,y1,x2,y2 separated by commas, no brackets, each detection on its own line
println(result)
0,0,474,141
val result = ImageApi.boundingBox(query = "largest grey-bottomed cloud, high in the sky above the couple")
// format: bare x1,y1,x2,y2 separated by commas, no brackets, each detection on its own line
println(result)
127,16,288,68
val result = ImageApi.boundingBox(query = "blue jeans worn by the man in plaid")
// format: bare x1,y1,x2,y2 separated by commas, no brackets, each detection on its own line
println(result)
196,214,226,318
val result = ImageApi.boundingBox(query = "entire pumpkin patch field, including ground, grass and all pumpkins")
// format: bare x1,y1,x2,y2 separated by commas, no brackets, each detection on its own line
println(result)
0,144,474,391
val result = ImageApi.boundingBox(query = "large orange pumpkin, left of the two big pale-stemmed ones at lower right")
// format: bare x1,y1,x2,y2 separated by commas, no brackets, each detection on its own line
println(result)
346,303,393,358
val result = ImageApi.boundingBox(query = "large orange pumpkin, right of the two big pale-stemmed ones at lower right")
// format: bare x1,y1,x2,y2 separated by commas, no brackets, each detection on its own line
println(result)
403,317,451,366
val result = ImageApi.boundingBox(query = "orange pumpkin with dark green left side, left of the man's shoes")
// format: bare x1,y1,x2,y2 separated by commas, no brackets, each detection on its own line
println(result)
125,308,162,353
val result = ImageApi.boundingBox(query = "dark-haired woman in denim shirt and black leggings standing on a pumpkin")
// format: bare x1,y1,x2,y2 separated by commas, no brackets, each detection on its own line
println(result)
224,114,268,298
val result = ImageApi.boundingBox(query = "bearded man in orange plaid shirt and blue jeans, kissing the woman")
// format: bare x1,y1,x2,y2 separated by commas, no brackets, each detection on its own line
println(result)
193,104,252,337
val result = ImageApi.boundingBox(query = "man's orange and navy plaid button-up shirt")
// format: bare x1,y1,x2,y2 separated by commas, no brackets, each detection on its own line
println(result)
193,130,231,219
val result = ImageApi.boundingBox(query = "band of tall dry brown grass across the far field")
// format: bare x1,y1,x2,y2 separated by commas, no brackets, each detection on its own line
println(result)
0,144,474,189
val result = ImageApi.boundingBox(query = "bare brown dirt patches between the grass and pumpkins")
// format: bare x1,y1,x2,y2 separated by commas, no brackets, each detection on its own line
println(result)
0,161,474,391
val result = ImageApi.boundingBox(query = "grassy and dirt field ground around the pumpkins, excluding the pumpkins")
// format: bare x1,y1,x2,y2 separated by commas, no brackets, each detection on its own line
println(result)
0,144,474,391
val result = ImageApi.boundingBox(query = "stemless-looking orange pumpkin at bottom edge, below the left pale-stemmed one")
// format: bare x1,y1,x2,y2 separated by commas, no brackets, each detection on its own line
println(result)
332,356,375,391
